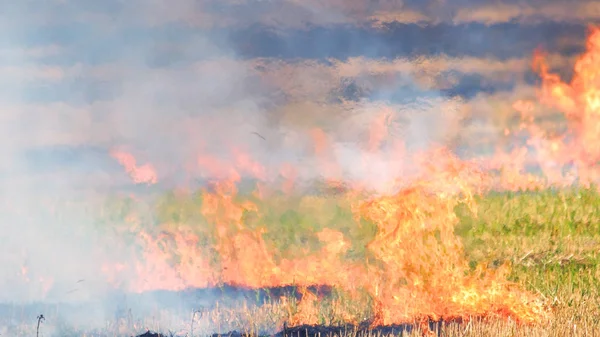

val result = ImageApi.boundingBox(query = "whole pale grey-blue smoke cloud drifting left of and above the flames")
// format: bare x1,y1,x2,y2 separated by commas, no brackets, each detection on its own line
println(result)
0,1,592,334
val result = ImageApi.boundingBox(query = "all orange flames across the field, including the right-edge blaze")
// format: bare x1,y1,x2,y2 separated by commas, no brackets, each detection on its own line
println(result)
102,28,600,334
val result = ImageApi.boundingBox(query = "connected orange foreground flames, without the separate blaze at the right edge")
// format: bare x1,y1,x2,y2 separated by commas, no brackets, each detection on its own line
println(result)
102,148,547,325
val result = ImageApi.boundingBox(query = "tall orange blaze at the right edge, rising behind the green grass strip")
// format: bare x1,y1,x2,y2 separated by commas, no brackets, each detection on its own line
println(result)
490,27,600,190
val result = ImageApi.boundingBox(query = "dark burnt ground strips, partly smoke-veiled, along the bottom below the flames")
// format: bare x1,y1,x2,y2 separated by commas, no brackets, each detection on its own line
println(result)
0,285,444,337
